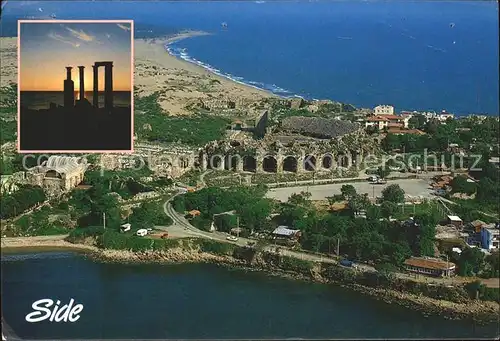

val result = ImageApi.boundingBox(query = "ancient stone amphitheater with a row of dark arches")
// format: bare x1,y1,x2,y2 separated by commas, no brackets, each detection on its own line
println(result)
198,112,377,173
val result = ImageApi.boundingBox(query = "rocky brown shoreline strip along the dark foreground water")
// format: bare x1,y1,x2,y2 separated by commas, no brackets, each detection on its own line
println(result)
1,237,498,324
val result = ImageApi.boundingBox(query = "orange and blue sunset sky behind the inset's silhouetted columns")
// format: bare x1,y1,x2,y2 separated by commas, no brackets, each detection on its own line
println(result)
20,22,132,91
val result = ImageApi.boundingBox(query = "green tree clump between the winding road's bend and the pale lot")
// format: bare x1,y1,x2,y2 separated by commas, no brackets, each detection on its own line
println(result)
173,186,272,230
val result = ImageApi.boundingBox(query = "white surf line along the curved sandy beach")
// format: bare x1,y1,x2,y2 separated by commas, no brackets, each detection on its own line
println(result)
164,43,294,98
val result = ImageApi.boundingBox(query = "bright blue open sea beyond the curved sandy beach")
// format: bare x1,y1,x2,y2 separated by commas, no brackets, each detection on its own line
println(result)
5,1,499,115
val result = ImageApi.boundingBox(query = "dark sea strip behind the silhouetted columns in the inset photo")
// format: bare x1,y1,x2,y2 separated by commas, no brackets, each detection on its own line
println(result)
20,91,131,110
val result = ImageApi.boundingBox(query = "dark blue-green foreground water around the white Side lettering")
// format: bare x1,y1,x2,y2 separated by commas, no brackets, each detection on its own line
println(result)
1,251,499,340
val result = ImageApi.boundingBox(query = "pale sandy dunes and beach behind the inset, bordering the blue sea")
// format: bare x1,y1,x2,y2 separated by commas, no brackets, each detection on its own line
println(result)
0,31,277,116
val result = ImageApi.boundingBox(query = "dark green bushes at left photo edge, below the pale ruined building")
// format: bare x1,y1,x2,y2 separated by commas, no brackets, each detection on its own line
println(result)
0,185,46,219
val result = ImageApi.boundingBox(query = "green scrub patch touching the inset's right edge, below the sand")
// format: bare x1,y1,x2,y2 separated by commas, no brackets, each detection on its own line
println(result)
134,93,229,146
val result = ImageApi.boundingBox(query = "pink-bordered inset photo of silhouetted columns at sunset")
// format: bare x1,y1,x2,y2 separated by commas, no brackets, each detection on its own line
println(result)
17,20,134,153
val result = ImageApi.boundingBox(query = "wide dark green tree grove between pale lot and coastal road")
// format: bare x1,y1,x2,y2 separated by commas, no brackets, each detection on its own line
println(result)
277,185,443,266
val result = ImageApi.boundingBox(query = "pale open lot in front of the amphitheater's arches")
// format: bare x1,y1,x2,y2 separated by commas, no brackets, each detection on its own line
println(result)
266,178,433,202
